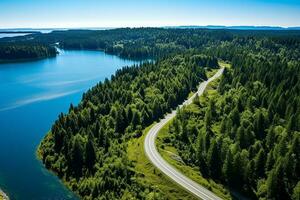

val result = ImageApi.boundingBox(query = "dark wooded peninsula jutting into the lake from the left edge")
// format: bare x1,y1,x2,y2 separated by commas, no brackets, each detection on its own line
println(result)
0,43,57,63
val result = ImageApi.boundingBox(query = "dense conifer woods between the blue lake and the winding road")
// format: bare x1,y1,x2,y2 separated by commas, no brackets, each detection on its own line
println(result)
39,54,218,199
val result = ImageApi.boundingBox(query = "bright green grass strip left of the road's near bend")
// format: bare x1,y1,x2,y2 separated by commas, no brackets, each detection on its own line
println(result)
127,124,197,200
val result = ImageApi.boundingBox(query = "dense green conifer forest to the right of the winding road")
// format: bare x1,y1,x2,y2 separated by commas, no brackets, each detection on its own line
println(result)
166,55,300,199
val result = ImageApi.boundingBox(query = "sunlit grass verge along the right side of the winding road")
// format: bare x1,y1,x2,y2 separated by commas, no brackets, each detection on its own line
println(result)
152,65,231,199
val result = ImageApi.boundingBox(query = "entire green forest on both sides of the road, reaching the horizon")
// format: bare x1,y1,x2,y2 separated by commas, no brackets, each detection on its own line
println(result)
0,28,300,199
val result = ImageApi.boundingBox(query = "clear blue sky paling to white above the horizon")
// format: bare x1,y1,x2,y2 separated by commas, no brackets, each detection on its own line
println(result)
0,0,300,28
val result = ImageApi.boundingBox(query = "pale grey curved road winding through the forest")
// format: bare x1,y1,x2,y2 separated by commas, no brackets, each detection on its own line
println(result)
144,68,224,200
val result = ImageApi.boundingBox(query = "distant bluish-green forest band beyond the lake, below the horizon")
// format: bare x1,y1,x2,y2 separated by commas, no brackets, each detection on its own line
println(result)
0,28,300,60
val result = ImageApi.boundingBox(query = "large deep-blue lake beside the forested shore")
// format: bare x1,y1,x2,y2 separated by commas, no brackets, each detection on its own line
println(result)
0,51,136,200
